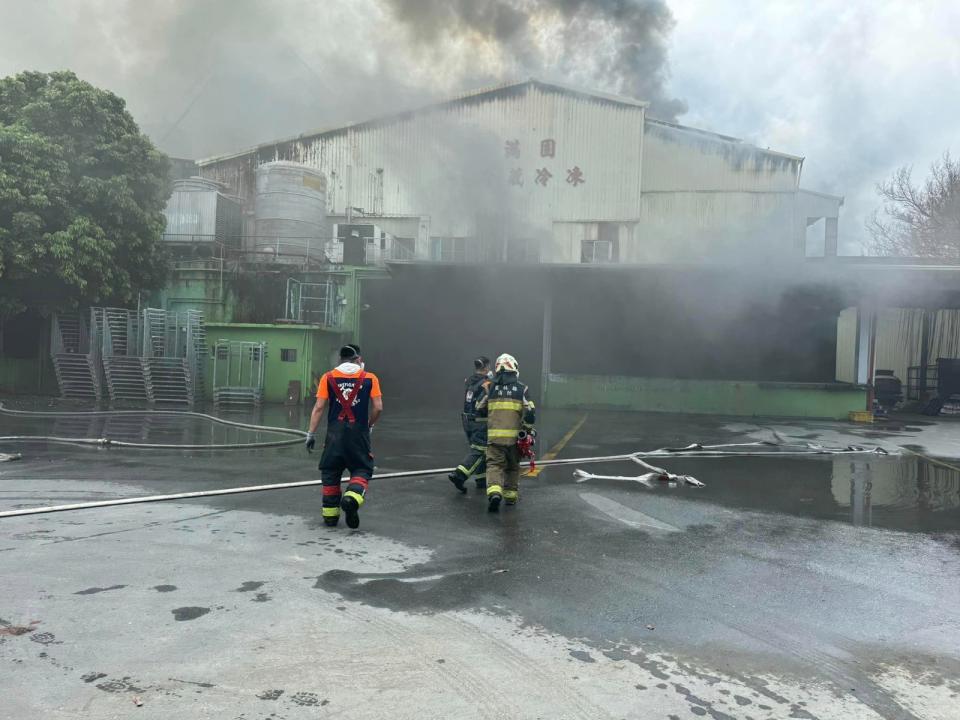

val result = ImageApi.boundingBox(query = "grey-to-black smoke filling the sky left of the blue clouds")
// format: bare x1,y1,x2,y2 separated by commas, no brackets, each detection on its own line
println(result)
0,0,684,158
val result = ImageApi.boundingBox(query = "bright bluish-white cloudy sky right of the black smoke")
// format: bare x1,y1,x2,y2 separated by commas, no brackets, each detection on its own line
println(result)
670,0,960,254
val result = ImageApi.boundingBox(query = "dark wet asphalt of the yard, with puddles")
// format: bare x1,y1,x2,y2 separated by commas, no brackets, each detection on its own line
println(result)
0,405,960,718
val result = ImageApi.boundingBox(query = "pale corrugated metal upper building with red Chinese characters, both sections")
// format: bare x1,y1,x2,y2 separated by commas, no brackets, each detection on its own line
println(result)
199,79,842,263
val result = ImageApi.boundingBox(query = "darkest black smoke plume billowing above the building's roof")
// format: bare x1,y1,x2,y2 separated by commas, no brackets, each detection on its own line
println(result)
385,0,687,120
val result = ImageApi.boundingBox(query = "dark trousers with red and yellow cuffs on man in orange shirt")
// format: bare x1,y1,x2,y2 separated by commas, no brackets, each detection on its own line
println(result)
320,421,373,518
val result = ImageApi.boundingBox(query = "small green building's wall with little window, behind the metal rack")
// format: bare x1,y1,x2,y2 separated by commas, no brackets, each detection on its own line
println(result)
207,323,349,402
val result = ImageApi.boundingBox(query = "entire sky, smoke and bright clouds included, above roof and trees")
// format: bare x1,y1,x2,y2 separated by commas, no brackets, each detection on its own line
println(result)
0,0,960,254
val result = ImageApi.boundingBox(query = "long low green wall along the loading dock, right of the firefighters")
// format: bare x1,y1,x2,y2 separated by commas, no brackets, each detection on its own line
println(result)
544,374,867,420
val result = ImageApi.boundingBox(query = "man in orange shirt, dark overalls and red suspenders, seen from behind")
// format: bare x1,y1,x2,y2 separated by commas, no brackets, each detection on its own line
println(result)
306,345,383,528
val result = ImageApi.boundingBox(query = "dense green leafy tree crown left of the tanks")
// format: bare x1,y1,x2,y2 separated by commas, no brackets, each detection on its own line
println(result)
0,72,170,317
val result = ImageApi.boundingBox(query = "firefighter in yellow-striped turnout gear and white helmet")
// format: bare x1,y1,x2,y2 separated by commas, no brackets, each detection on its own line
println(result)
477,353,537,512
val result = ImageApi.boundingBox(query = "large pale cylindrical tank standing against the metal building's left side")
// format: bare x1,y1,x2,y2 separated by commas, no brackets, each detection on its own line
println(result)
250,162,330,264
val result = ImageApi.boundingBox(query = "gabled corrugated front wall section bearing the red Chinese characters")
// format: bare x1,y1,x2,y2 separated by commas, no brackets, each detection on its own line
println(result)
202,85,644,237
